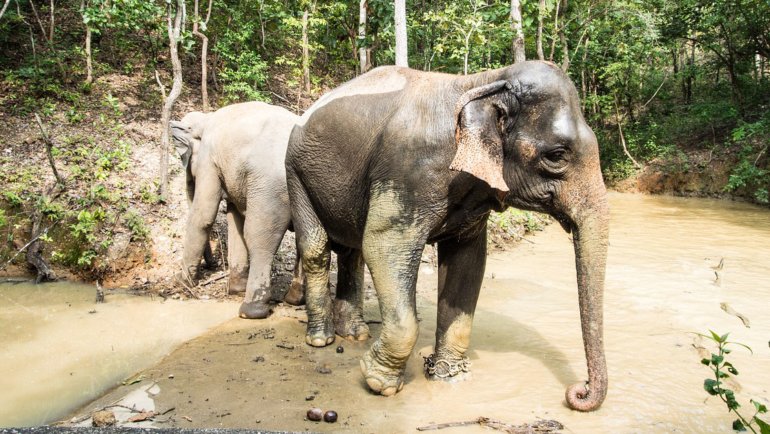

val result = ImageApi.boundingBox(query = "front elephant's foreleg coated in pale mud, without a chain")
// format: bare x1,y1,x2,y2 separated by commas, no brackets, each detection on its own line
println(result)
361,185,427,396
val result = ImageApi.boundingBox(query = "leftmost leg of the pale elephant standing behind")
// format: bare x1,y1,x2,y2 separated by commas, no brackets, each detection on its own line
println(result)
176,176,222,287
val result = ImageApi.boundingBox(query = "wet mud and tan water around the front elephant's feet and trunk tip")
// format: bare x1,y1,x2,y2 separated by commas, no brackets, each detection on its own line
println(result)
64,194,770,433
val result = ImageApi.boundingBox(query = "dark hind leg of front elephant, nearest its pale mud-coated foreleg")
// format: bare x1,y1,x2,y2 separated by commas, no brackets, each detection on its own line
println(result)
334,249,369,341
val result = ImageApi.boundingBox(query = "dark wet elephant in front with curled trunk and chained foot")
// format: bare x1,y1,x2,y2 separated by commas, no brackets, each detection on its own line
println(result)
286,62,609,411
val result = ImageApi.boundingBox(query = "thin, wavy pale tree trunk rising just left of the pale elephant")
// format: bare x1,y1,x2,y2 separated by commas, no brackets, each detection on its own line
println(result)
159,0,186,202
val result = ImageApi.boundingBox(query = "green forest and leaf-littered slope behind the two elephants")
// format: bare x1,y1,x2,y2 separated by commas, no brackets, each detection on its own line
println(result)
0,0,770,284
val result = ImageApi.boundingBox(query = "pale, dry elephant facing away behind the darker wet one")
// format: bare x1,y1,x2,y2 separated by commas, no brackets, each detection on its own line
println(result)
171,102,304,318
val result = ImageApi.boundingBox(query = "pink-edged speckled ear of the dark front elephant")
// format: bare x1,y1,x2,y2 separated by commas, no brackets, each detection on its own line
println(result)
449,80,517,192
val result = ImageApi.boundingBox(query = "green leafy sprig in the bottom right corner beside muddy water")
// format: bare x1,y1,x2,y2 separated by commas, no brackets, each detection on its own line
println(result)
698,330,770,434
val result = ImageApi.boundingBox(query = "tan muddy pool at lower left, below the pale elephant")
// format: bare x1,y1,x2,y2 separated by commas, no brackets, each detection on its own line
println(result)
0,283,237,427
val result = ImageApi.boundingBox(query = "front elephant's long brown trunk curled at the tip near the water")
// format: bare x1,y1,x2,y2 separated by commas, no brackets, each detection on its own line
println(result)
566,183,609,411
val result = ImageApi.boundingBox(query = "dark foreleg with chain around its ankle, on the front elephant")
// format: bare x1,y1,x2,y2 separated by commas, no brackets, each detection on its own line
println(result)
426,223,487,380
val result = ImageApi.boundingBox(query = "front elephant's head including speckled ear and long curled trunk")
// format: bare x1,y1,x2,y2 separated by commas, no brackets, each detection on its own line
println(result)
451,62,609,411
